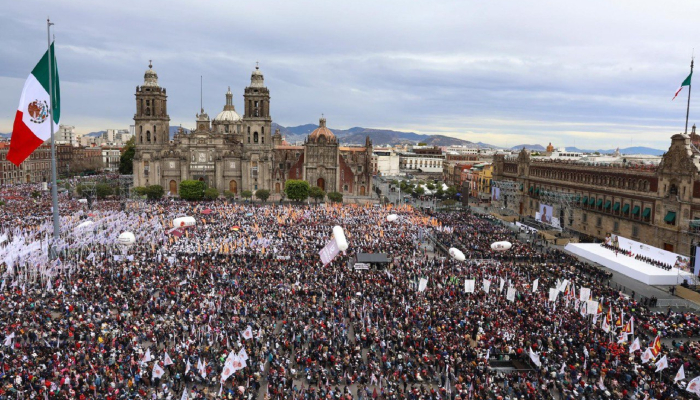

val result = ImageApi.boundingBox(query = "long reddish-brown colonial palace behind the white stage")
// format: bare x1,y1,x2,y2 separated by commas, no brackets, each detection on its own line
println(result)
493,134,700,255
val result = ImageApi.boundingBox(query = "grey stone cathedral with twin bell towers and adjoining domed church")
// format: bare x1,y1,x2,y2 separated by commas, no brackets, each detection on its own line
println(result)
134,65,372,197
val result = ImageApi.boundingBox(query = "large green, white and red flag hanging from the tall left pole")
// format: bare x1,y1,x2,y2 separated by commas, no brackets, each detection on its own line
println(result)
7,43,61,166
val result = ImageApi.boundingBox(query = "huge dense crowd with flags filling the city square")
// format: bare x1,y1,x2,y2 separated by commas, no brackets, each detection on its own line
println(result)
0,186,700,400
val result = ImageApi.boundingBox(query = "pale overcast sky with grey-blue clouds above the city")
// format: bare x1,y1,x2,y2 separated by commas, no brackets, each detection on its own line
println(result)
0,0,700,149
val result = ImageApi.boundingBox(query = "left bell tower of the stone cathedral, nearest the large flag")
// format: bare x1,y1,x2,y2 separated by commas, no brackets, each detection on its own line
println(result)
134,63,170,147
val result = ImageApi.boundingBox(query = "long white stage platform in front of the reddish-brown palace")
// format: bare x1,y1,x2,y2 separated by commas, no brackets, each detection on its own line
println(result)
564,243,693,285
